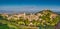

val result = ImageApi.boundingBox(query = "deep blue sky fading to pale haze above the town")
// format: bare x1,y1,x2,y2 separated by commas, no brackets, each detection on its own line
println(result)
0,0,60,12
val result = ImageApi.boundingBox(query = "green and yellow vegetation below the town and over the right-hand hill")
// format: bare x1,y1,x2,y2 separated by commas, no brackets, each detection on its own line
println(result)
0,10,60,29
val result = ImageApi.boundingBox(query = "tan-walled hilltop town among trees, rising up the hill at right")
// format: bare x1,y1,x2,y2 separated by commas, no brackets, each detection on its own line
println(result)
0,10,60,28
